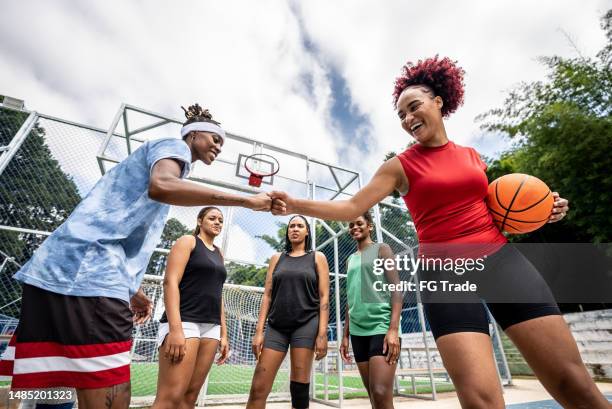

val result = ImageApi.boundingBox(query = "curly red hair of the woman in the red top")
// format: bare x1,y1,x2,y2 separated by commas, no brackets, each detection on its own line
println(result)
393,55,465,117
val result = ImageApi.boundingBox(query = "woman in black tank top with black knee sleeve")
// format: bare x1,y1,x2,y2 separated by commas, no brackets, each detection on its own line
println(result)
247,216,329,409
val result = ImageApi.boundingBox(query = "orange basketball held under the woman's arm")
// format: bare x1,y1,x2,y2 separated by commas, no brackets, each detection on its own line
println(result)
487,173,554,234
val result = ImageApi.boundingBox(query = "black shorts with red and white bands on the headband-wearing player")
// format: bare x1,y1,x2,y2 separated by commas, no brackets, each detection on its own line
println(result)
0,284,132,389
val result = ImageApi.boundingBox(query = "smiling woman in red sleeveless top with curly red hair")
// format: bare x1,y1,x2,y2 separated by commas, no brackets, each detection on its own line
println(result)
271,57,610,409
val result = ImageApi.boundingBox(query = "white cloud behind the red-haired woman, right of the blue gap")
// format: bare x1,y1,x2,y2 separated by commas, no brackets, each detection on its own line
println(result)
292,0,612,174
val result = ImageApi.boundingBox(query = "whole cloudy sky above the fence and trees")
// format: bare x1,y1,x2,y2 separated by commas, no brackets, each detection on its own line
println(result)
0,0,612,180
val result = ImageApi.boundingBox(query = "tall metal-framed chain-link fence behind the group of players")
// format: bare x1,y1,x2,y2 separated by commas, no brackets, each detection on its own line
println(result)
0,105,510,405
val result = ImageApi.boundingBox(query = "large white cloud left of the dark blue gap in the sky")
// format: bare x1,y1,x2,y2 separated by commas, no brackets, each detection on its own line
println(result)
0,0,337,162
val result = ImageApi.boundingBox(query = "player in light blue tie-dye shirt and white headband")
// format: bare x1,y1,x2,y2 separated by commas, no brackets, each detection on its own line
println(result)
0,104,272,409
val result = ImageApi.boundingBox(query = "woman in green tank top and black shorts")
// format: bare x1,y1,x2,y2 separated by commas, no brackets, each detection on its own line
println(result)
340,212,402,408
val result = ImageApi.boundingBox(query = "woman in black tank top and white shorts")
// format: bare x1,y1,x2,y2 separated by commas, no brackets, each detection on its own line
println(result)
152,207,229,408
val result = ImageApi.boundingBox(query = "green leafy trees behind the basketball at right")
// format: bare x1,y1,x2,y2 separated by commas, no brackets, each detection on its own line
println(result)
480,10,612,243
